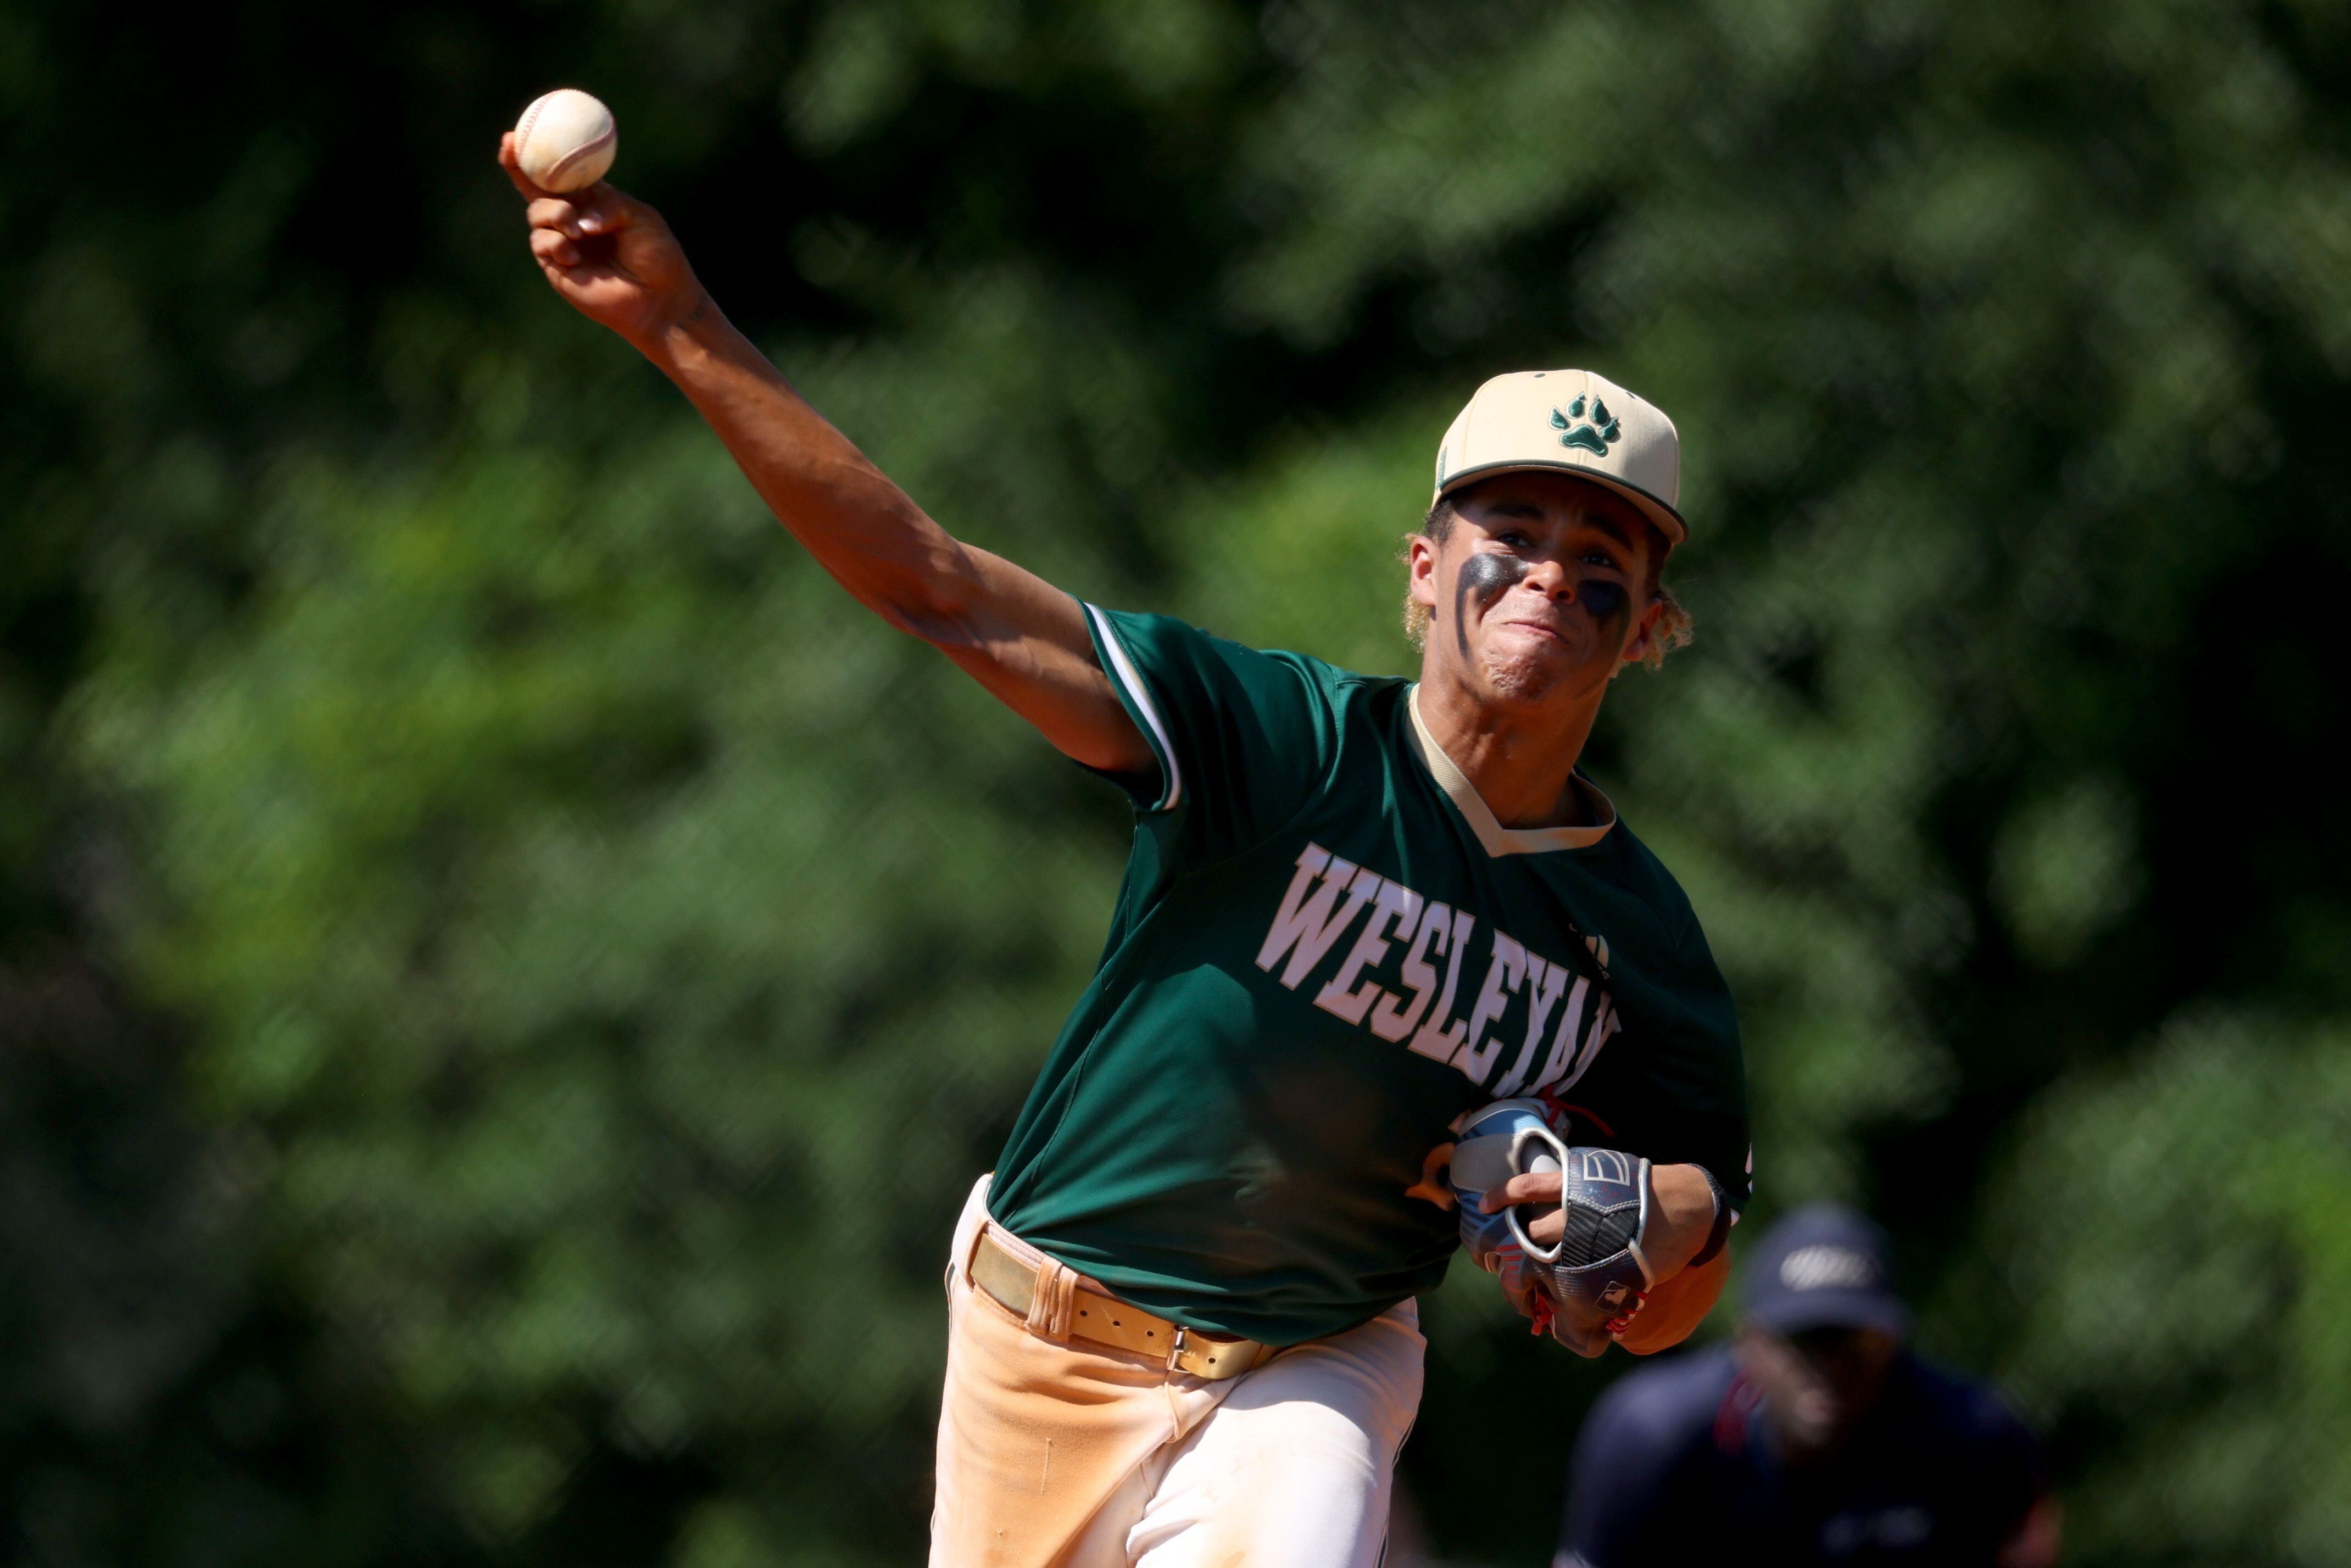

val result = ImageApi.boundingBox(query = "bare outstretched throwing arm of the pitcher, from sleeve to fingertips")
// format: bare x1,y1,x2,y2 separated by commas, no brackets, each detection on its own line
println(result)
498,134,1157,773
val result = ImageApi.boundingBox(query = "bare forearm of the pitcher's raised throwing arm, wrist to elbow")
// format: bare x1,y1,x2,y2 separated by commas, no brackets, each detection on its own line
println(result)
639,296,983,644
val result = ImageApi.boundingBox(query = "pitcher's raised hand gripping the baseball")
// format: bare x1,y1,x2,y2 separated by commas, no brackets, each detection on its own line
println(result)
498,132,707,353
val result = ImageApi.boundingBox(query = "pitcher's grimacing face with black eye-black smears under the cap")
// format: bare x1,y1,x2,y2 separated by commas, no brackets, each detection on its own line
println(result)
1413,472,1660,701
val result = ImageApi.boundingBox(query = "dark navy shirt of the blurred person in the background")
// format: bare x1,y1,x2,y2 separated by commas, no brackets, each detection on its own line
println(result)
1559,1349,2043,1568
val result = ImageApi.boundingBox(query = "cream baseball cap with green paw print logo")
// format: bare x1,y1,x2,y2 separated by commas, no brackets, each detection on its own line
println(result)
1429,369,1690,545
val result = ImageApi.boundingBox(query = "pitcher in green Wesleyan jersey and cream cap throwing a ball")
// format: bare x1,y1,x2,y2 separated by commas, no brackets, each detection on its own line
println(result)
501,141,1749,1568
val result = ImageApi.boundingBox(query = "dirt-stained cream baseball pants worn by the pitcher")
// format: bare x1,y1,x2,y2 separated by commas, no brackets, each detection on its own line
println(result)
931,1178,1427,1568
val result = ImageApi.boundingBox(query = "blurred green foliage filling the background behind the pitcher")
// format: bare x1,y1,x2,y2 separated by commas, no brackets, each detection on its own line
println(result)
0,0,2351,1568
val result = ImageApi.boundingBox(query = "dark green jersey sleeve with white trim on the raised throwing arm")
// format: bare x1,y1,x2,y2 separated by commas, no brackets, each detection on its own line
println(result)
1086,604,1338,863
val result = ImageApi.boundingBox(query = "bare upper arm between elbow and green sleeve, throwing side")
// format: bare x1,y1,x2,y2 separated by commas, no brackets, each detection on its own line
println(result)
900,545,1157,773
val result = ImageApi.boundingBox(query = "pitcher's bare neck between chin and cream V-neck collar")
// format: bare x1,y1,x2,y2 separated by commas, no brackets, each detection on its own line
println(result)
1420,661,1606,828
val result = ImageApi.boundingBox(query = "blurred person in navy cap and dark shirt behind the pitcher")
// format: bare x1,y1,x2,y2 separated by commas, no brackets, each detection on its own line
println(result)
1554,1204,2057,1568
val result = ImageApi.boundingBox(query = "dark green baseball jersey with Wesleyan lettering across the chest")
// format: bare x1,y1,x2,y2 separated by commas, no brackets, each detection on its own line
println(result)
988,606,1749,1344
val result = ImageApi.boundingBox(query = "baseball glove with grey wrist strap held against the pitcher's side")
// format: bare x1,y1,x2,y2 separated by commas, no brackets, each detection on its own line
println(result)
1448,1100,1655,1357
